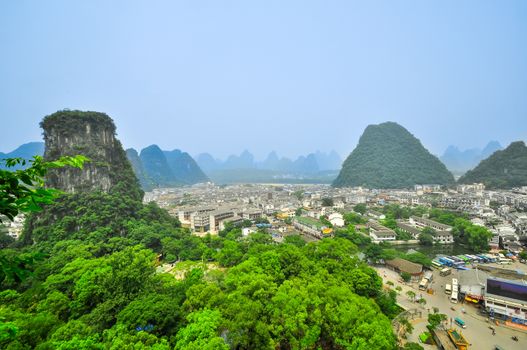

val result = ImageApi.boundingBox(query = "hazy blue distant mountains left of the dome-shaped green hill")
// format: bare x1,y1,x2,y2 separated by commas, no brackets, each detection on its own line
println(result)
0,142,342,186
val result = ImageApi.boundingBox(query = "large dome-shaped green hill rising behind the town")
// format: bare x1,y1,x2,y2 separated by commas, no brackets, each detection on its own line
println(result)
333,122,455,188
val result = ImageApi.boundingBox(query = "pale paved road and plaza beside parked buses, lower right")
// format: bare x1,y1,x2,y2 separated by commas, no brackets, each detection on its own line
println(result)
376,268,527,350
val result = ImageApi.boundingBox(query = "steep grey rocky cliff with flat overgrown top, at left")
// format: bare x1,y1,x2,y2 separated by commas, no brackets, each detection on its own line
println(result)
40,111,142,197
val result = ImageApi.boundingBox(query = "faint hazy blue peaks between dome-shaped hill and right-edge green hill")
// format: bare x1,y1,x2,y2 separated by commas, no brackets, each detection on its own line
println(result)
440,141,502,175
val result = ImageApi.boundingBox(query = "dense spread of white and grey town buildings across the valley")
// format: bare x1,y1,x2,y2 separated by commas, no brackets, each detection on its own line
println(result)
140,183,527,250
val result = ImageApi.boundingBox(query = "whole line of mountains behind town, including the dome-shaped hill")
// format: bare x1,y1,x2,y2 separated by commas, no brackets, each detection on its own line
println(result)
0,138,527,190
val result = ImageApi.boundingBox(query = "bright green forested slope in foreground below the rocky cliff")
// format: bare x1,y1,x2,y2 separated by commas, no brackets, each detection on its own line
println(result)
0,113,399,350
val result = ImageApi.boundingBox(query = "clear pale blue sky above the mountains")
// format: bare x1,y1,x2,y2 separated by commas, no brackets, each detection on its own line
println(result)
0,0,527,159
